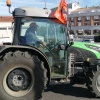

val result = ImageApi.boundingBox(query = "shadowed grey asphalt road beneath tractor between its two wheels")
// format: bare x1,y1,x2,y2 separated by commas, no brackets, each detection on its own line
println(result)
40,83,100,100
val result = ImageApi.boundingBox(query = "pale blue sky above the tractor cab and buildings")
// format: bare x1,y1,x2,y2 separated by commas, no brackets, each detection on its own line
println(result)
0,0,100,16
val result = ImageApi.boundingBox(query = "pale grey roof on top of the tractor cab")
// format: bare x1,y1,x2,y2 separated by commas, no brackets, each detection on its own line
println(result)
14,7,55,18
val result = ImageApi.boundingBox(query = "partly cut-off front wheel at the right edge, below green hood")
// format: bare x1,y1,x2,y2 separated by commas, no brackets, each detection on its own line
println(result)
86,66,100,97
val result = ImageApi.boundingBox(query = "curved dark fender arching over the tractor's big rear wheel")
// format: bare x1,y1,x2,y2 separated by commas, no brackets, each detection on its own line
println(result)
0,45,51,81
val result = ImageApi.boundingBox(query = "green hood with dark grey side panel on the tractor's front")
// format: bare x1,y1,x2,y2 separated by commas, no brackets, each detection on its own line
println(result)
70,41,100,61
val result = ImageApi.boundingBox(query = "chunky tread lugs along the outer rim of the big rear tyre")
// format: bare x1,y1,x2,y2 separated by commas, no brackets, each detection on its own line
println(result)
0,50,48,100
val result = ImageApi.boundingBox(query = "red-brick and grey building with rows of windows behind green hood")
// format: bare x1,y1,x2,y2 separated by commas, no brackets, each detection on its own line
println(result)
68,3,100,35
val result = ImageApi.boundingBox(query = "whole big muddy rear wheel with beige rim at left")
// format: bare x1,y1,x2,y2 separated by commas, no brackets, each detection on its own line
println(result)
0,51,45,100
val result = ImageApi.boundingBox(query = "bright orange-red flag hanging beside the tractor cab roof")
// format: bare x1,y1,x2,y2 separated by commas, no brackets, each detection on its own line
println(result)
54,0,68,24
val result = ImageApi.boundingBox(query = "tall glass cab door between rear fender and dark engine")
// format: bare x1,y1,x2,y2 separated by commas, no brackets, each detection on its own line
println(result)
45,24,68,78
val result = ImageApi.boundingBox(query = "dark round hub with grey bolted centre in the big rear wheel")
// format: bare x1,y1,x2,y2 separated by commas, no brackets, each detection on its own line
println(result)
7,69,31,91
